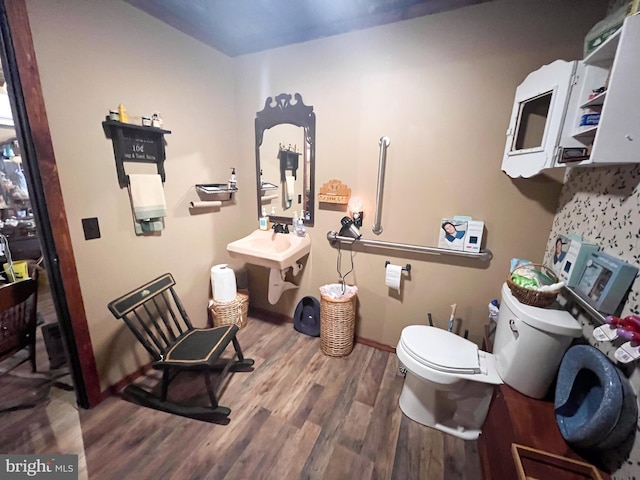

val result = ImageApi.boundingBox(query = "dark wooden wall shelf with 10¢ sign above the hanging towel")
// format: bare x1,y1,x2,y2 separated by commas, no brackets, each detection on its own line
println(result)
102,120,171,188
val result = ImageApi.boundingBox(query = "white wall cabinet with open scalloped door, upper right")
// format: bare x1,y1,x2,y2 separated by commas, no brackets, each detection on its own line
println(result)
502,15,640,178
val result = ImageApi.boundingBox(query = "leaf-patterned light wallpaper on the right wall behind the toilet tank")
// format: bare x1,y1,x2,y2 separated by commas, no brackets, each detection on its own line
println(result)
544,165,640,480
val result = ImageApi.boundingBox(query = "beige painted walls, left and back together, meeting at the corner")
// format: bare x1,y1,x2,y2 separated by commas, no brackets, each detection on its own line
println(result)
23,0,604,388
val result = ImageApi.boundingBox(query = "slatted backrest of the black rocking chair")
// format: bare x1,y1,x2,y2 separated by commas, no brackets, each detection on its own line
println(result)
108,273,193,360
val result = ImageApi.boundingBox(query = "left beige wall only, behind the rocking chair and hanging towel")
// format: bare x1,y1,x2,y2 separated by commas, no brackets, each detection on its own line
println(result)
27,1,257,388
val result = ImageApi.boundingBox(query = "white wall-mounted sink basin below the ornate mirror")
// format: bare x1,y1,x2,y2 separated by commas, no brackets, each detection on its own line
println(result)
227,230,311,270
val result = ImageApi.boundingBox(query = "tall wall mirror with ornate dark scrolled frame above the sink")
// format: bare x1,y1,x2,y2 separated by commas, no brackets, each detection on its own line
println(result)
255,93,315,225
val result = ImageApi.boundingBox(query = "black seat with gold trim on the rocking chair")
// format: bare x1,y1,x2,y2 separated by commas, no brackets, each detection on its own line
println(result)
161,325,238,368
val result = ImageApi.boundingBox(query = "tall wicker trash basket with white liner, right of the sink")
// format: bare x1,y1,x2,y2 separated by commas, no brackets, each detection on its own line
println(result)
320,284,358,357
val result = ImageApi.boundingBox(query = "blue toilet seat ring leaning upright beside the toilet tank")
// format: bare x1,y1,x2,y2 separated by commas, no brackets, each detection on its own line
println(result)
554,345,638,450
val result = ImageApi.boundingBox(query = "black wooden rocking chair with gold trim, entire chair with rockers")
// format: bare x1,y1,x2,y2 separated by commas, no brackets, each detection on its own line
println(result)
108,273,253,420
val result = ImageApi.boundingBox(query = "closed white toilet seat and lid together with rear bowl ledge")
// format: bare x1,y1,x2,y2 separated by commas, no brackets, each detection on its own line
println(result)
397,325,503,384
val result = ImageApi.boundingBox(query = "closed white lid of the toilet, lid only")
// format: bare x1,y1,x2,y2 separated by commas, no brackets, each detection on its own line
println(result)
400,325,480,374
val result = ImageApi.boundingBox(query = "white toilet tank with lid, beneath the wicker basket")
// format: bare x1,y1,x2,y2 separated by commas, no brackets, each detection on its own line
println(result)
493,283,582,398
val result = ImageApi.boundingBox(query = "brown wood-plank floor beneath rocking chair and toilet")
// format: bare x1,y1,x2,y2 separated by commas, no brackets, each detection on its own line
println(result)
0,318,481,480
